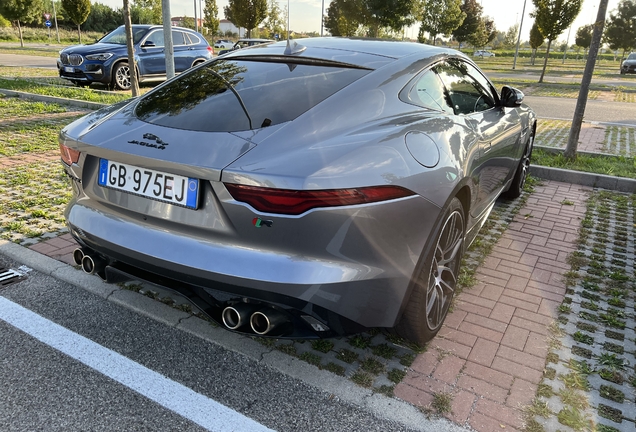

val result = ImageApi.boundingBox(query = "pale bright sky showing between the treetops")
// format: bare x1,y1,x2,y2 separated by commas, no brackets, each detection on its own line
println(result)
93,0,619,44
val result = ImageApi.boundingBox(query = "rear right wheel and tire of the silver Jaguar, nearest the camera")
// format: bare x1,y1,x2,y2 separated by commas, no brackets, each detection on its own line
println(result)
394,198,466,345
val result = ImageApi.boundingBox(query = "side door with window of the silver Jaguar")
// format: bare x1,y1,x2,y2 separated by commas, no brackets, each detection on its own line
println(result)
436,59,521,217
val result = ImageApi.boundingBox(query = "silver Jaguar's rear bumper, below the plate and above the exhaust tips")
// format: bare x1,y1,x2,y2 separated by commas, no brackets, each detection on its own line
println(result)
66,189,439,327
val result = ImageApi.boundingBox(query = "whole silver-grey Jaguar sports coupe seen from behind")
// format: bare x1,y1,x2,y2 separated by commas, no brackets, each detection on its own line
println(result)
60,38,536,343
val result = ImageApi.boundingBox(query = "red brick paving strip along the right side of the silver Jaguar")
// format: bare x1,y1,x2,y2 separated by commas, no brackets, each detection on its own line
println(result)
395,182,591,432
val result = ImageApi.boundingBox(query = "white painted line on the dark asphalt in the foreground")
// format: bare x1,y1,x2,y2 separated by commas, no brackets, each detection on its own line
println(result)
0,296,271,432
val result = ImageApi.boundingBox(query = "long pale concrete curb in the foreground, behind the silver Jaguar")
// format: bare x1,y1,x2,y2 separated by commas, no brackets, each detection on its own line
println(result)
0,240,466,432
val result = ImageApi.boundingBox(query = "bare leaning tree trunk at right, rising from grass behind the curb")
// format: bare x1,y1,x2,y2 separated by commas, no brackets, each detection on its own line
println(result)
563,0,608,160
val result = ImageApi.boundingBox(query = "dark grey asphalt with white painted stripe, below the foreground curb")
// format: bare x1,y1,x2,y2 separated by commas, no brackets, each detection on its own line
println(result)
0,251,464,432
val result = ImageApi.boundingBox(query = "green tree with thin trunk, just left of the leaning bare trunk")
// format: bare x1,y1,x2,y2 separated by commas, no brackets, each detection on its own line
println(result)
530,0,583,83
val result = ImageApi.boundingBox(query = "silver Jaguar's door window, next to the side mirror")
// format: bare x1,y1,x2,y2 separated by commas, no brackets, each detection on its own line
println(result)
435,63,495,114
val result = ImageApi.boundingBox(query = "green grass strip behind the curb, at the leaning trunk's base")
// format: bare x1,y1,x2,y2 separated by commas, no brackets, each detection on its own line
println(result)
532,149,636,178
